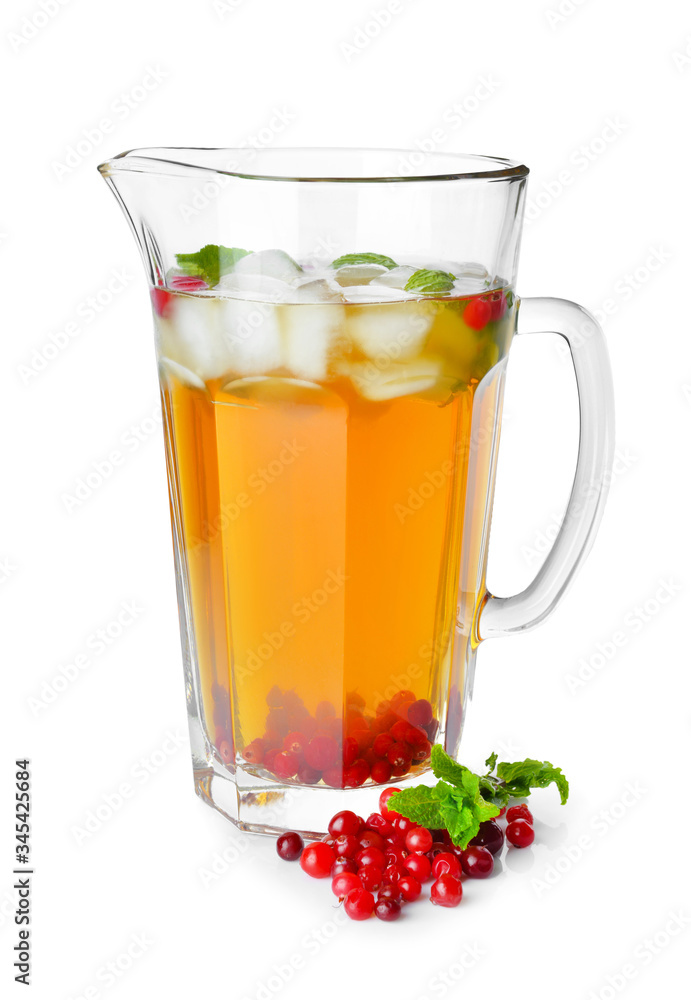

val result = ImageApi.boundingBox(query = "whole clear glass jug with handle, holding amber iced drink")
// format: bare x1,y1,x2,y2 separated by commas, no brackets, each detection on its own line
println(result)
99,149,613,834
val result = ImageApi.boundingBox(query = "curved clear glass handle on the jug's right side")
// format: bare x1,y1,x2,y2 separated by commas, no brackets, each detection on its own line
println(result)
476,298,614,640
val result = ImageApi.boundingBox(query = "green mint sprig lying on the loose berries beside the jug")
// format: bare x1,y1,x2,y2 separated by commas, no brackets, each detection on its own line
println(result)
386,745,569,848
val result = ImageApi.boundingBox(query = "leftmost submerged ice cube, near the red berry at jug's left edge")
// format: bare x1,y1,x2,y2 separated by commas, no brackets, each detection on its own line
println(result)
158,295,235,381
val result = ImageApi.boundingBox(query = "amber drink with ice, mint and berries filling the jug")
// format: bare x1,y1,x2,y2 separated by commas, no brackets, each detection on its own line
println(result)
152,251,515,788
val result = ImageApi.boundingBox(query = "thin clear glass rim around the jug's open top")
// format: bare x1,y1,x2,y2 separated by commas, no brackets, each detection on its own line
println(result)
98,146,529,184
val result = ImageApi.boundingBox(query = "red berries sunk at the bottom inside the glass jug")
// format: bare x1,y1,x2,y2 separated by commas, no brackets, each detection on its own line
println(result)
242,686,438,788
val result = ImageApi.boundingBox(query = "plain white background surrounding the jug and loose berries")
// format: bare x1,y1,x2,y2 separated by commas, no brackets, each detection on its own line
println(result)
0,0,691,1000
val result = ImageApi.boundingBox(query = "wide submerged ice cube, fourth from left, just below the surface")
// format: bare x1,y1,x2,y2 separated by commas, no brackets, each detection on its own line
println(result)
346,302,435,361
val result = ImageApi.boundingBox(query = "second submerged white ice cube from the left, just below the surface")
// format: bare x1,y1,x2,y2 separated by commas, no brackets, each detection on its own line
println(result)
219,299,283,375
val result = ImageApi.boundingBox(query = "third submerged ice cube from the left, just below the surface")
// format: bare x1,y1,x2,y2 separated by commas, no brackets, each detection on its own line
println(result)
281,303,345,381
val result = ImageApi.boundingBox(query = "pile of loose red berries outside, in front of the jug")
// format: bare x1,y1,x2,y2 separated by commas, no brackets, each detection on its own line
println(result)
276,788,535,920
